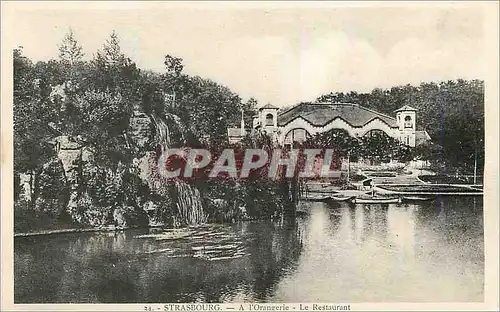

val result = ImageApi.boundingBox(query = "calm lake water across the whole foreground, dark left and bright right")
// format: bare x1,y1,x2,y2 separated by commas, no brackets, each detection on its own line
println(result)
14,197,484,303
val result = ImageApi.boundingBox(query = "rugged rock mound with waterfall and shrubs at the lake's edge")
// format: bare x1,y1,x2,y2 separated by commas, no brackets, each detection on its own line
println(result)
13,111,208,232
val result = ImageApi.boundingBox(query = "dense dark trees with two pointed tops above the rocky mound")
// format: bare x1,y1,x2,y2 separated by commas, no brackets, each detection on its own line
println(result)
14,32,257,171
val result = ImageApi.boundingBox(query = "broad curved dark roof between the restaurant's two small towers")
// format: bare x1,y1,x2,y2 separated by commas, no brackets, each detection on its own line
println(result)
278,103,397,127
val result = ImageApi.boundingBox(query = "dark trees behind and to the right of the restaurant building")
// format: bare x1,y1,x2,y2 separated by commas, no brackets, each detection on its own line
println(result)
317,79,484,174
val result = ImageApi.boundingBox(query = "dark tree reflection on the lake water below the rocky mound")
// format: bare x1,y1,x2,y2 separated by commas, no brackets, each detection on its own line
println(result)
15,222,303,302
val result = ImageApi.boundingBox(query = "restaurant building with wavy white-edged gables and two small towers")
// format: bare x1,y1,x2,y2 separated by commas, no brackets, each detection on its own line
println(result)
228,103,430,147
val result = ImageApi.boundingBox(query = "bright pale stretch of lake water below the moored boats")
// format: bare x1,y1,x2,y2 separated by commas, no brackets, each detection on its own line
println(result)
272,197,484,302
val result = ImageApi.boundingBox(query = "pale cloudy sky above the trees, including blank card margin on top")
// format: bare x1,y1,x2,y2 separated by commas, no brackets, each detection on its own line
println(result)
2,1,486,107
